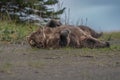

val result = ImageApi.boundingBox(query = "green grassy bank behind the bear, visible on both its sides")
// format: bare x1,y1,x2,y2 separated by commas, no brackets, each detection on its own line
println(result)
0,21,120,43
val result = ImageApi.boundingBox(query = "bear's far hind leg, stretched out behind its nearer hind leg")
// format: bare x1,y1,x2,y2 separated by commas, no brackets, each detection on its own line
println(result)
78,25,103,38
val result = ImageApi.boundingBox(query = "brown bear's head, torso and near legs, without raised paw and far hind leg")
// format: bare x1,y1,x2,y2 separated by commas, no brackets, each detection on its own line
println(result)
28,25,109,48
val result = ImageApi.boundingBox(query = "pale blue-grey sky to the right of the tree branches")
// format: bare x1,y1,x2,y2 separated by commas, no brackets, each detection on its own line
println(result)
62,0,120,32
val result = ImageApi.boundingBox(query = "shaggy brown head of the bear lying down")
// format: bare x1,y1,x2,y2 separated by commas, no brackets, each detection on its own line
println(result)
27,27,53,48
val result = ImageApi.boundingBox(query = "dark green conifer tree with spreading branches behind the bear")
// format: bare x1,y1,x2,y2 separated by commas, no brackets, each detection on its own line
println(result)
0,0,65,21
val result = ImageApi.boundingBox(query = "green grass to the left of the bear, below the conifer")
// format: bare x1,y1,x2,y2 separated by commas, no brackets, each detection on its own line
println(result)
0,21,38,43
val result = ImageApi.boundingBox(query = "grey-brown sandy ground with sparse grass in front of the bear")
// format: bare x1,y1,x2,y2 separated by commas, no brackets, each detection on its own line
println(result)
0,44,120,80
